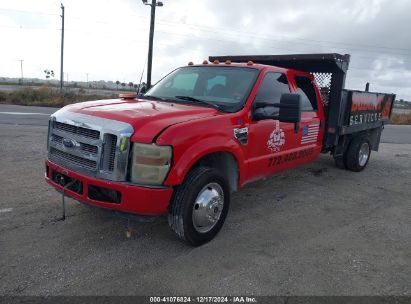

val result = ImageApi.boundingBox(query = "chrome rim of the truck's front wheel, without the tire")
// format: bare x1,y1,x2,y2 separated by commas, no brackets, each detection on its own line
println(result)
193,183,224,233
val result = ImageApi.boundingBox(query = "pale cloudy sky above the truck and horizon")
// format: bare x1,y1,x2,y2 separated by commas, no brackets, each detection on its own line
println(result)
0,0,411,101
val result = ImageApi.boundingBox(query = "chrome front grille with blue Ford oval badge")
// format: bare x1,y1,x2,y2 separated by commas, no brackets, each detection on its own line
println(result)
48,113,134,181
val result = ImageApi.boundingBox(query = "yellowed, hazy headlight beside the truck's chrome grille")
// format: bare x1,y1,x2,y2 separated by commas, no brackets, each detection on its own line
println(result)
131,143,173,185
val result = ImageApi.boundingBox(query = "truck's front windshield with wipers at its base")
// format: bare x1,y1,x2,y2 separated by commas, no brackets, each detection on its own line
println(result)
145,66,259,112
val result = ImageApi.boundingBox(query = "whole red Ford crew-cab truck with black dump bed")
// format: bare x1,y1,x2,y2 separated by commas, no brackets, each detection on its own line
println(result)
45,54,395,245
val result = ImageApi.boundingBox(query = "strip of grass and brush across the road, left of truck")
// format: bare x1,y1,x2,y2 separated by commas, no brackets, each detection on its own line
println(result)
0,86,116,107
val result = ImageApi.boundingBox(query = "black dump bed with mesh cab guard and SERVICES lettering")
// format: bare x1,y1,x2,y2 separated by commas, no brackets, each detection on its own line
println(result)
209,53,395,149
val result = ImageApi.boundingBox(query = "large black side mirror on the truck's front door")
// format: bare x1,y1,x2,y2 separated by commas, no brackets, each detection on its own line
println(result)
252,94,301,124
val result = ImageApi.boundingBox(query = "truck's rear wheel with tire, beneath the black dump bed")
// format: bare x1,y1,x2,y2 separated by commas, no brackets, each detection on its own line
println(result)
346,137,371,172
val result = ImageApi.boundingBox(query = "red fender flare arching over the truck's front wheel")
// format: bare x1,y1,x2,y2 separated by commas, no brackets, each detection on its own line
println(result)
165,136,247,186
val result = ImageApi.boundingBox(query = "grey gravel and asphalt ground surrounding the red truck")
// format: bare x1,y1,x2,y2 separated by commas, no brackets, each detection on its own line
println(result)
0,106,411,295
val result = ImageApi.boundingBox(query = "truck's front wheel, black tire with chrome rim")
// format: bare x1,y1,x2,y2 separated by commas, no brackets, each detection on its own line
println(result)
168,166,230,246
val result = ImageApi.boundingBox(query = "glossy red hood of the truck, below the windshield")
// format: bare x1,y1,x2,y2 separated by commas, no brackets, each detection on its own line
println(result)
65,99,219,143
